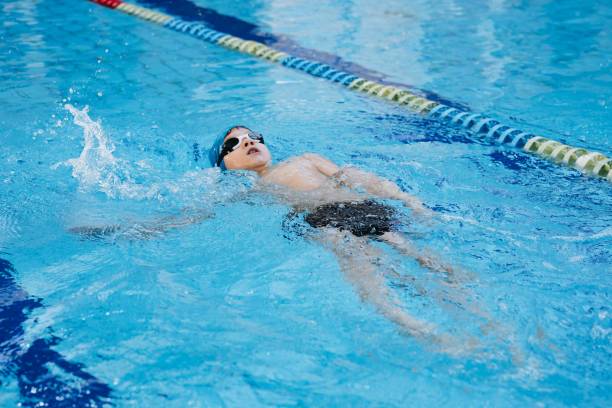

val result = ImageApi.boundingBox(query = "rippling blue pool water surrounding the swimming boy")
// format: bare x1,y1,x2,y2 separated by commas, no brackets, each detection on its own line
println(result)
0,0,612,406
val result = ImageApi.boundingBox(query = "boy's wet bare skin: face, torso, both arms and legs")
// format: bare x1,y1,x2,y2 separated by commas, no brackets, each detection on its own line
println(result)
71,128,498,353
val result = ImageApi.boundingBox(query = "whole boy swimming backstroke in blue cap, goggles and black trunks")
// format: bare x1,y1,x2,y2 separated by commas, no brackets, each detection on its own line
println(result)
71,126,502,350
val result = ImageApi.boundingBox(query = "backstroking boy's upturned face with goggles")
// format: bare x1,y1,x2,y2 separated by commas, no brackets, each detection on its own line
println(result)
223,127,272,170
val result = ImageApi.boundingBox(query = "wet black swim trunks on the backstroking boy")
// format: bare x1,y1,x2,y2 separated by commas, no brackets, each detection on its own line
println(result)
304,200,396,237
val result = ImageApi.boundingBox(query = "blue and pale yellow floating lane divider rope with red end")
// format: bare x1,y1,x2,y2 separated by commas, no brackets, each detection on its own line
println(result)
90,0,612,182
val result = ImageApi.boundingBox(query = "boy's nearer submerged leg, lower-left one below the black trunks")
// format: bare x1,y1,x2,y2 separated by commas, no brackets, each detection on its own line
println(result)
317,228,441,343
